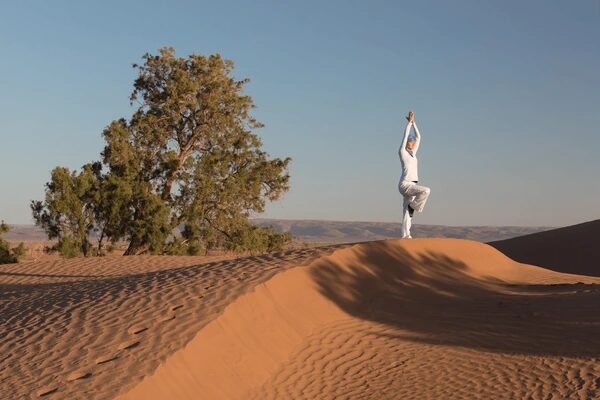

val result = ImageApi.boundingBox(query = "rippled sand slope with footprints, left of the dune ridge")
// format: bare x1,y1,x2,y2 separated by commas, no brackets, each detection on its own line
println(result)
0,246,346,400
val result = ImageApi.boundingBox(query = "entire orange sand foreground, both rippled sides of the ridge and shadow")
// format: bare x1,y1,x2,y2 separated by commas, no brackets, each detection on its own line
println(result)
0,239,600,399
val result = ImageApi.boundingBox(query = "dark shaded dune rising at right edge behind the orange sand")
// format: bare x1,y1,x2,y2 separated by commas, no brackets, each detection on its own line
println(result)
489,220,600,276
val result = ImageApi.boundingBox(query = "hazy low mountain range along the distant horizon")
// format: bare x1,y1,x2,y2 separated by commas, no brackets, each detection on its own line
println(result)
4,219,552,243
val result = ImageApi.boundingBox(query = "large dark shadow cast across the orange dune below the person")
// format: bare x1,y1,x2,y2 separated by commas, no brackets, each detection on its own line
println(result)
311,242,600,357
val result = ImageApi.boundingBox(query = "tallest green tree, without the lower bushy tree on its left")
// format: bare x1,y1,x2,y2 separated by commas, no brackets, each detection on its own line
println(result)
103,48,290,254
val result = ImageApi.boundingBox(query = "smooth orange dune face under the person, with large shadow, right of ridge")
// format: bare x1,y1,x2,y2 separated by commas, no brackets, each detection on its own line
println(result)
120,239,600,399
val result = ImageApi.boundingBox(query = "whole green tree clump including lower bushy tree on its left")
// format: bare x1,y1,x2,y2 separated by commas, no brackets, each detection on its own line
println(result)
31,48,290,255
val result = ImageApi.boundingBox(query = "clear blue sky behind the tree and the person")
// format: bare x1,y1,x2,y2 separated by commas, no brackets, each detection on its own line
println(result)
0,0,600,226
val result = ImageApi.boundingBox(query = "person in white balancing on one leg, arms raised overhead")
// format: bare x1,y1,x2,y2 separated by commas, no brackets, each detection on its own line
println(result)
398,111,431,239
